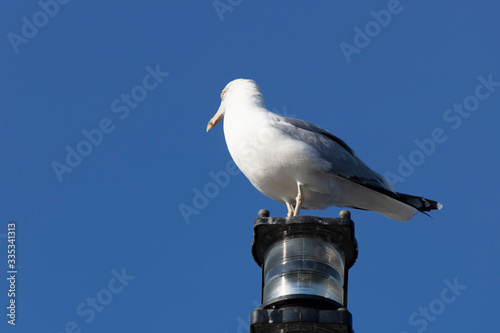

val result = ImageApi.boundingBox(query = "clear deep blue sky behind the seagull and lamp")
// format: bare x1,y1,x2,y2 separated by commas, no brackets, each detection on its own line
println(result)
0,0,500,333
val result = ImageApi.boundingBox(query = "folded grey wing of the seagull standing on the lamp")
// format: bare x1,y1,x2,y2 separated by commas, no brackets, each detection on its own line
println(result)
271,115,395,193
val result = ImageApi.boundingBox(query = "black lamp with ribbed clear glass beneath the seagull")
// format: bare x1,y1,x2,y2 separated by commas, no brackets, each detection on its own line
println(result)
250,210,358,333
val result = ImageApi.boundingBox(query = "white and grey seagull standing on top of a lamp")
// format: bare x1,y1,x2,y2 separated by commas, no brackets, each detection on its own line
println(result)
207,79,442,222
